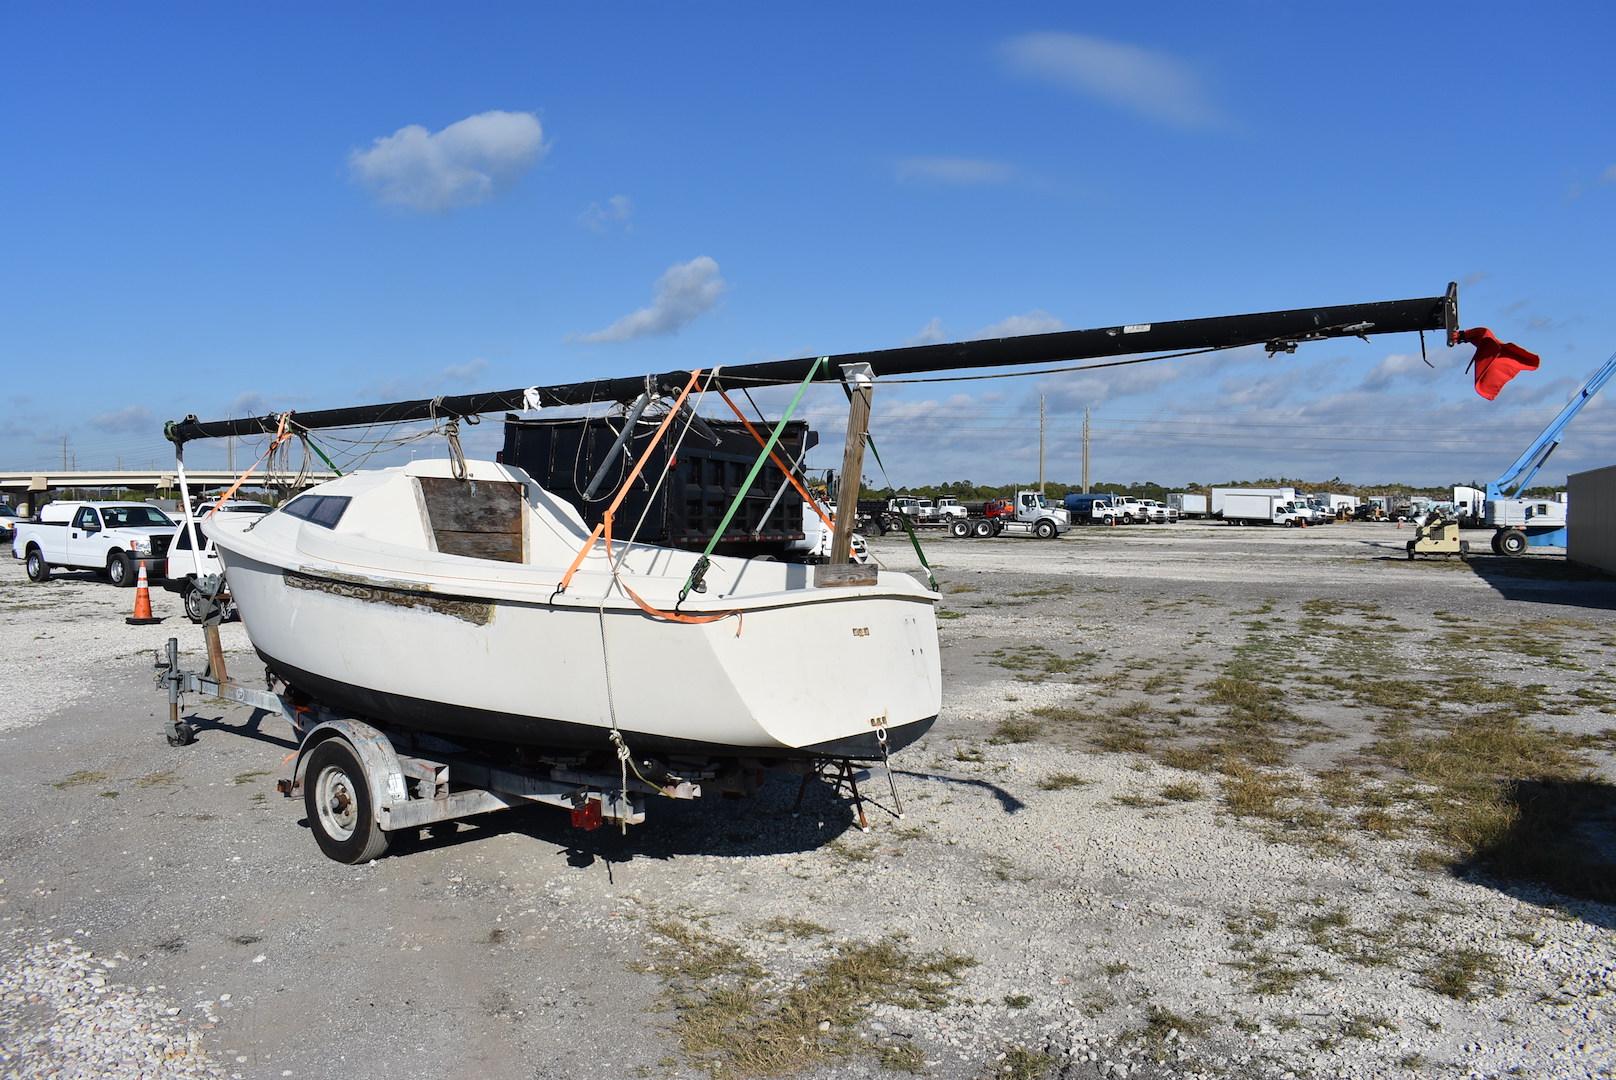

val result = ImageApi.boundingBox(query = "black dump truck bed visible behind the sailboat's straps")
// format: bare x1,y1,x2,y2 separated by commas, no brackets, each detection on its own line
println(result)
499,416,818,556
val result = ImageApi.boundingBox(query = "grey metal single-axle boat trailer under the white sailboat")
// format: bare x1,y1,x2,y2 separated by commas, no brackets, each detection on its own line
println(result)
157,637,704,863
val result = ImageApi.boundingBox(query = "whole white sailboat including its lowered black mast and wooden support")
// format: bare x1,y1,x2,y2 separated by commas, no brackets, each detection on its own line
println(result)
165,285,1458,763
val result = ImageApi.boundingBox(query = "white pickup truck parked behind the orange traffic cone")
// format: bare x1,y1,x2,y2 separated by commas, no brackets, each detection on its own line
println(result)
11,503,175,587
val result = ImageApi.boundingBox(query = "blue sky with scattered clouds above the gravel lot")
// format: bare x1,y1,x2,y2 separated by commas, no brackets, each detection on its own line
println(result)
0,3,1616,483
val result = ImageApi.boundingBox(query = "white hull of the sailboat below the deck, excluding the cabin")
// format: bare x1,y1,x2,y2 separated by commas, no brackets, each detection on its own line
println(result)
215,468,941,758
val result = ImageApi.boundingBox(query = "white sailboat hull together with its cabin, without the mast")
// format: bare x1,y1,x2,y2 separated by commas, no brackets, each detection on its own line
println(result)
208,459,942,760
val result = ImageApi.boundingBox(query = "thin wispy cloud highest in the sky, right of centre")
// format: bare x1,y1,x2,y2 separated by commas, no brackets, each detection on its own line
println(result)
1000,32,1223,128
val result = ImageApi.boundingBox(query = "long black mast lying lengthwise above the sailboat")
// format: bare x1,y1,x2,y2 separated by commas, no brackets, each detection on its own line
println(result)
163,283,1459,446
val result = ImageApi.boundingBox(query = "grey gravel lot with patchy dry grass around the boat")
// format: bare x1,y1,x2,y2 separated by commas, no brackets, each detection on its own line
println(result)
0,524,1616,1080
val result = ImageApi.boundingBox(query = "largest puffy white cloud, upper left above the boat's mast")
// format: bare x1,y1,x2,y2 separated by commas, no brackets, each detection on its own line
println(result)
347,110,545,212
